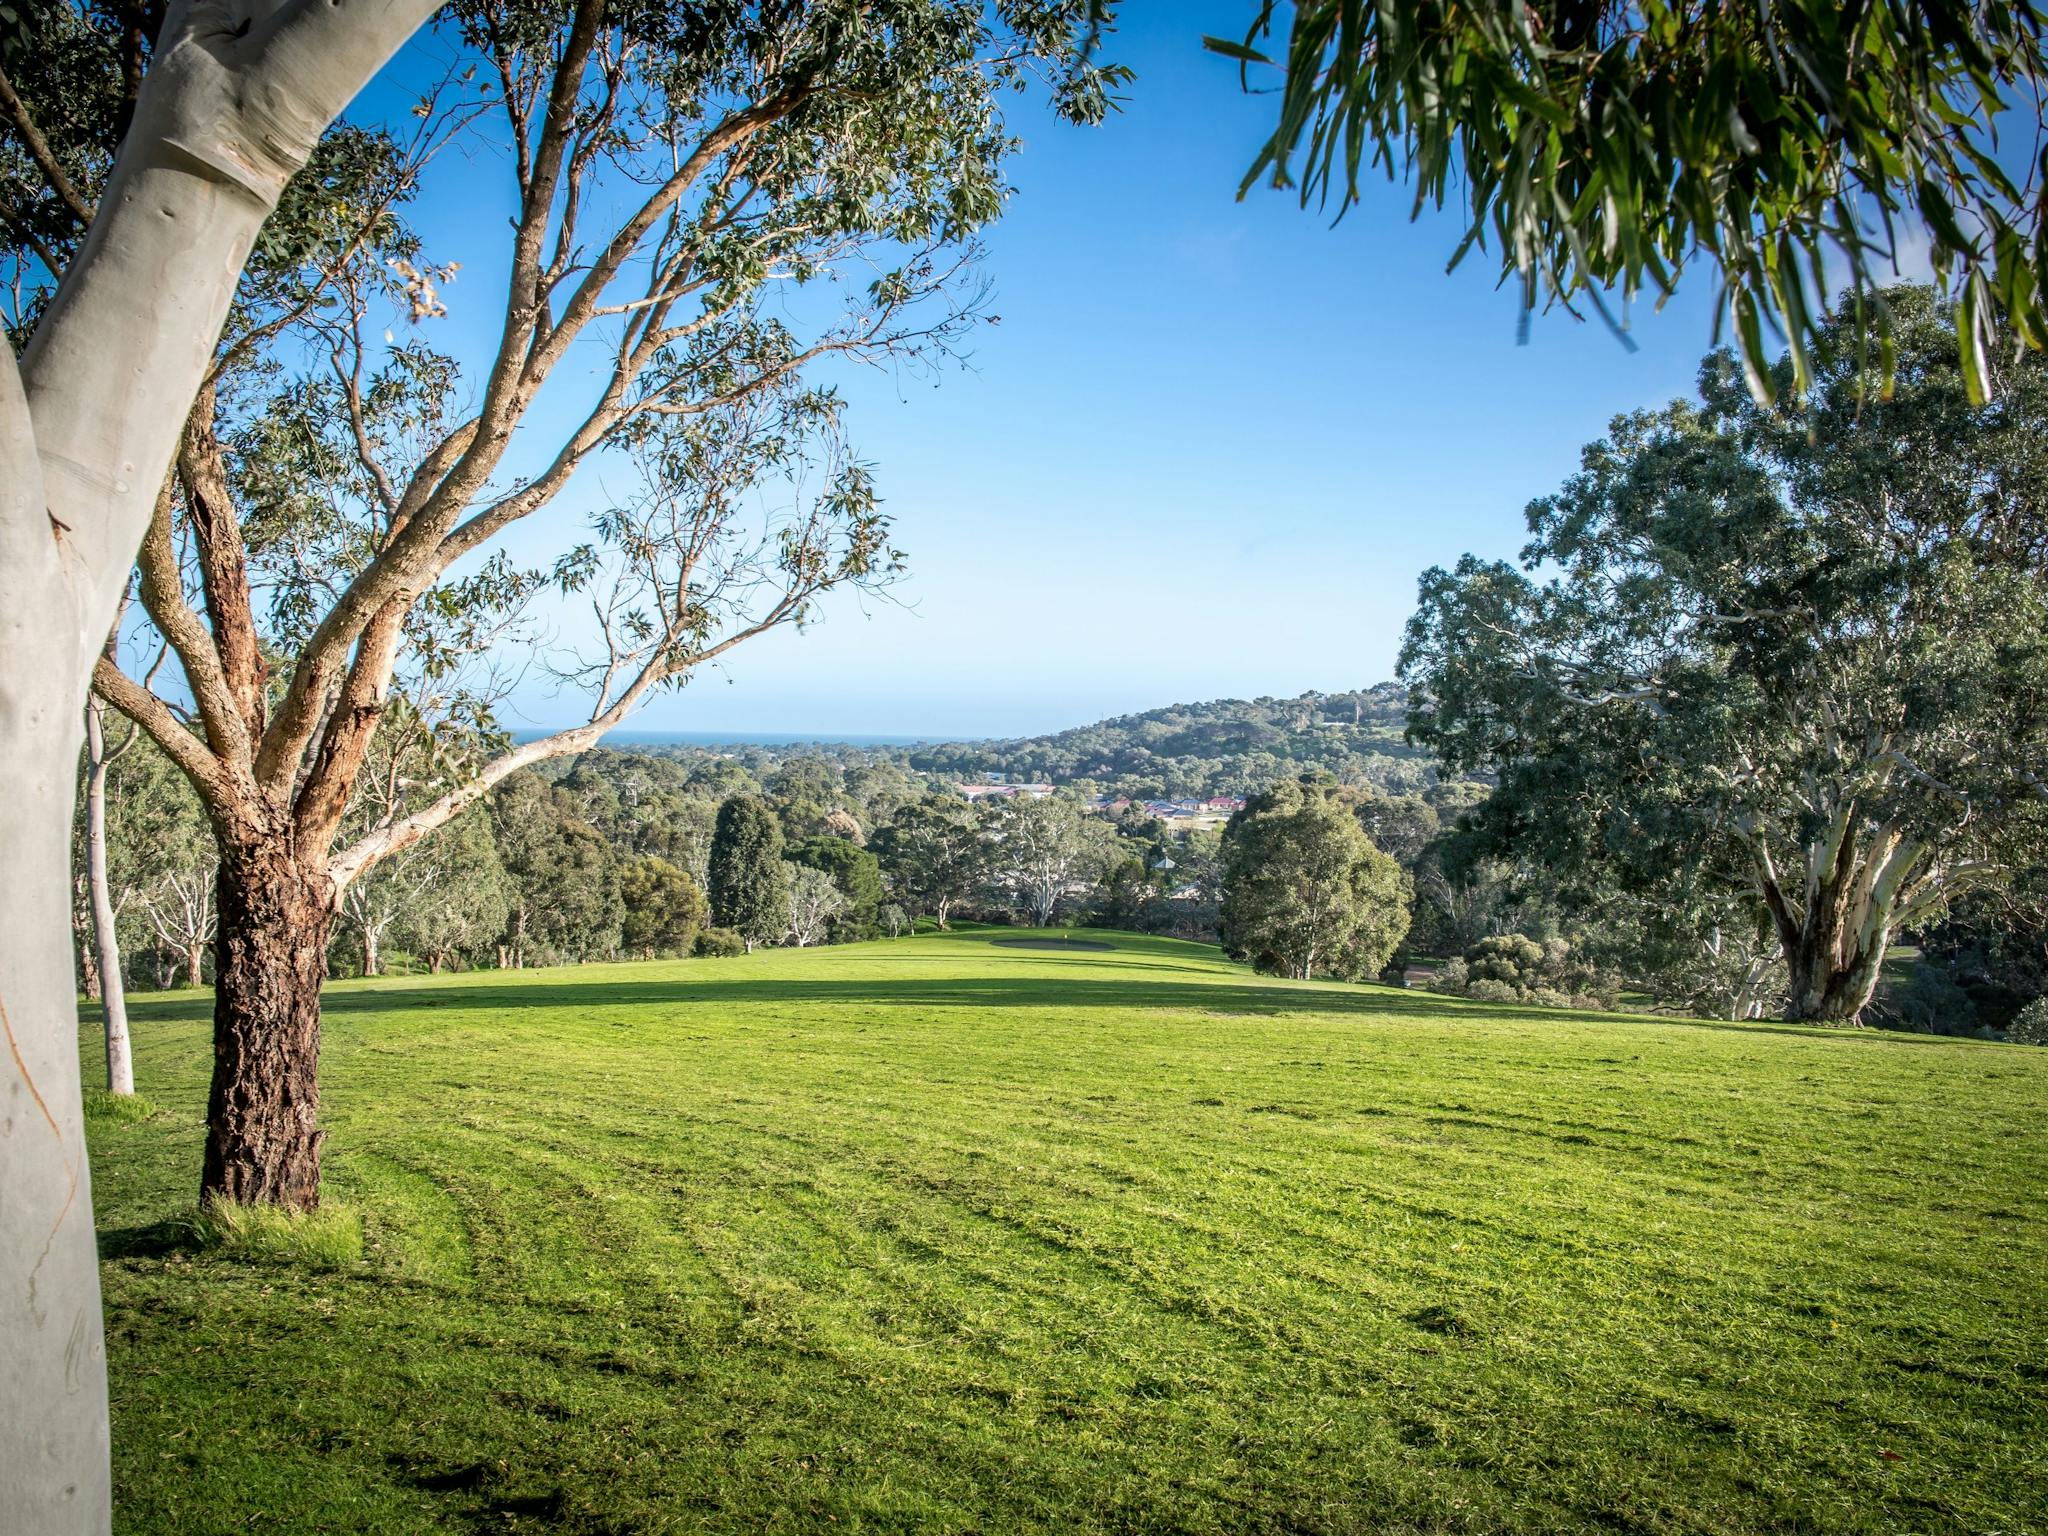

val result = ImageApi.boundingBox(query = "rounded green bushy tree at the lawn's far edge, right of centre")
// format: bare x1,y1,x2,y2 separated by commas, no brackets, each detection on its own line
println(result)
1221,780,1411,979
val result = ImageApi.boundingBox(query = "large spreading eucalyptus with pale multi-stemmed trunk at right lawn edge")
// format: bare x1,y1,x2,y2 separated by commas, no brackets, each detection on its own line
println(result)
1401,291,2048,1022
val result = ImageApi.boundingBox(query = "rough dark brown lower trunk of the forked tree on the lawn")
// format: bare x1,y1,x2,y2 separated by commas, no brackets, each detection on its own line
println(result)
201,838,334,1210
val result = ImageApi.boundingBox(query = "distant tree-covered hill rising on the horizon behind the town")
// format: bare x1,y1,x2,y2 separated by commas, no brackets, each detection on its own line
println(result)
905,682,1466,799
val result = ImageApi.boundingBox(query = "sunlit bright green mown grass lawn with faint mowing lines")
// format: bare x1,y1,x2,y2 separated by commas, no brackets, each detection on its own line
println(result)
88,934,2048,1536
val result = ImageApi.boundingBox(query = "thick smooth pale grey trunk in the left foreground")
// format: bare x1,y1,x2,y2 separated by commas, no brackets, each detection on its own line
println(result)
0,0,436,1536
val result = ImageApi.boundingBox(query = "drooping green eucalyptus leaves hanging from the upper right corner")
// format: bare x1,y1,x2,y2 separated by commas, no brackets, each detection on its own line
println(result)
1210,0,2048,401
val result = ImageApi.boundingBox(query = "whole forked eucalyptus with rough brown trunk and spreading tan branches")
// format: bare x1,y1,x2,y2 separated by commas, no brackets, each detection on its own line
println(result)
96,0,1100,1228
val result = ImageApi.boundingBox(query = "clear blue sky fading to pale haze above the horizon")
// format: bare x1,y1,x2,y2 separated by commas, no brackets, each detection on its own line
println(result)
364,0,1744,737
